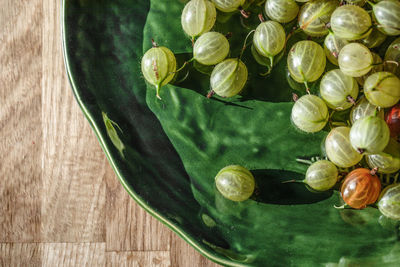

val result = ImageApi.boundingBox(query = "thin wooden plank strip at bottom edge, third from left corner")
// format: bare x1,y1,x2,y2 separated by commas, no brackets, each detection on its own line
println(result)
106,251,170,267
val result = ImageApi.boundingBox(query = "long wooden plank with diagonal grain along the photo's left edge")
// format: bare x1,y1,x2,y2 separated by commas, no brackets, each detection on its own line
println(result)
0,0,42,242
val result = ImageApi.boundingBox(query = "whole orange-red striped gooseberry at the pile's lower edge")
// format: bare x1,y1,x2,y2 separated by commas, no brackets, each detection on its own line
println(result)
340,168,381,209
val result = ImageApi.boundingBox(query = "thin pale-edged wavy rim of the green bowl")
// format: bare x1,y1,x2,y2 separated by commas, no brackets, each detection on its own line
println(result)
60,0,249,267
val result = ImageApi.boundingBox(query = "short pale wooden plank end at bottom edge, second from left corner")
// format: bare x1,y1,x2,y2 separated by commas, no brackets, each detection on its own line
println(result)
41,243,106,267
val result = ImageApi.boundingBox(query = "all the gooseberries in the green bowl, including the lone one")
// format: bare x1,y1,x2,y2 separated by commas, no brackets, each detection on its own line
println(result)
142,0,400,220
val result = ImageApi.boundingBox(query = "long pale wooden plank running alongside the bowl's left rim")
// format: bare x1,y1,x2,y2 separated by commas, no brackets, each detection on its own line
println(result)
41,0,108,242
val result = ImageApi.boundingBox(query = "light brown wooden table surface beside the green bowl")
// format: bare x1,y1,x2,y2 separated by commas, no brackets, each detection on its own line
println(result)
0,0,217,267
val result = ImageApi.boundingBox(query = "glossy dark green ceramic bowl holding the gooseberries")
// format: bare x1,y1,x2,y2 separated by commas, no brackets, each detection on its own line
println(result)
62,0,400,266
